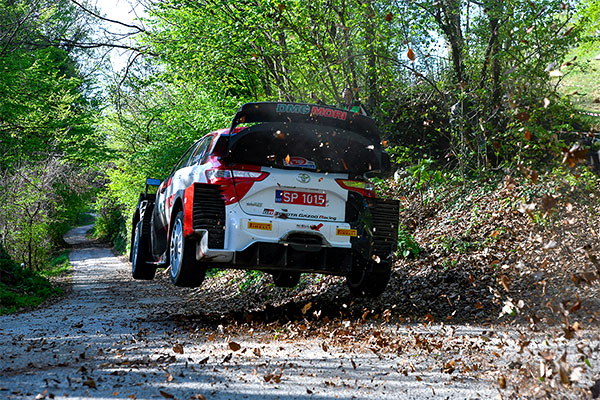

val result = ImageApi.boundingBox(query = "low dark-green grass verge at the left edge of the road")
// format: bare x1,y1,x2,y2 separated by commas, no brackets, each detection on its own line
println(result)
0,247,62,315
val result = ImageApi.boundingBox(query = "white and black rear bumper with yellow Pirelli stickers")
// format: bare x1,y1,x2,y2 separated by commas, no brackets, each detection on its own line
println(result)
189,181,399,275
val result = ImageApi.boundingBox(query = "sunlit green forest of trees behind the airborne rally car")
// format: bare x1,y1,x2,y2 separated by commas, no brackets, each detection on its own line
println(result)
0,0,600,310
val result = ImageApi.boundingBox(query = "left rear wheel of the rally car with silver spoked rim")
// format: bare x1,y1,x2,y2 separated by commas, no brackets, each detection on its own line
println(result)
169,211,206,287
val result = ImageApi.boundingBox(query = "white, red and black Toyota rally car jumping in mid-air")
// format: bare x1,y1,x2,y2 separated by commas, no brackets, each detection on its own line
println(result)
131,102,399,296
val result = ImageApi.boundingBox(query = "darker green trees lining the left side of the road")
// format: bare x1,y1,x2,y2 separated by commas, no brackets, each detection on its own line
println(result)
0,0,107,270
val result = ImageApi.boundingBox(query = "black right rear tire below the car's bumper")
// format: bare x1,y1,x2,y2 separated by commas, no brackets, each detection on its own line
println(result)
346,256,392,297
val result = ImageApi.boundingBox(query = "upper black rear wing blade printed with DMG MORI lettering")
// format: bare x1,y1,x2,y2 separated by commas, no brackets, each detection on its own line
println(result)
229,102,381,149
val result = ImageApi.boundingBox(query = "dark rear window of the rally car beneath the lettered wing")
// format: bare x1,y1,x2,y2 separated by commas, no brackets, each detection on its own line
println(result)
223,123,381,173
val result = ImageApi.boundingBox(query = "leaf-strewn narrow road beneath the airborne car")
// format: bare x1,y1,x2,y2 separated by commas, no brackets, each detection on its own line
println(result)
0,226,598,400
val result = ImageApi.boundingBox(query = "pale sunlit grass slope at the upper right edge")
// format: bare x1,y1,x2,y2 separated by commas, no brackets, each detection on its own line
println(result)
559,49,600,111
